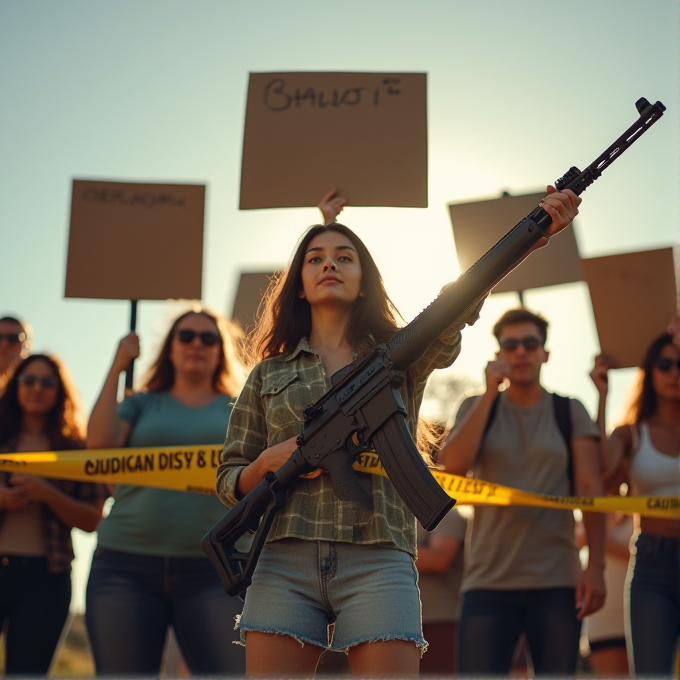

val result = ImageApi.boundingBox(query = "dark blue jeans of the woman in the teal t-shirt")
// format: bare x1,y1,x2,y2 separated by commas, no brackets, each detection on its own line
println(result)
85,548,245,676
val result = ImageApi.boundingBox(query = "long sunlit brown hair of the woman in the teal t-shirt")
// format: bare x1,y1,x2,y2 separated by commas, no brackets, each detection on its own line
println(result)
142,306,244,396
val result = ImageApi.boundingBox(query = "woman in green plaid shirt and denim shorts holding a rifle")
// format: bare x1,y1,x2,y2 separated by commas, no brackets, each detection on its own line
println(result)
217,189,580,677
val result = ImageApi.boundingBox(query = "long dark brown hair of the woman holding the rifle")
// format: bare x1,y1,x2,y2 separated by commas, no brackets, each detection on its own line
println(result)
247,223,401,364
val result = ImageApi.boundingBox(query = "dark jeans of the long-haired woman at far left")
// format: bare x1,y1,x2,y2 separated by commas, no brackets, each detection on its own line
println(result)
0,555,71,677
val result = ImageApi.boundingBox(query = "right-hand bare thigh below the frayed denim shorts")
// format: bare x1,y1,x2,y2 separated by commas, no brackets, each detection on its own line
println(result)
348,640,420,678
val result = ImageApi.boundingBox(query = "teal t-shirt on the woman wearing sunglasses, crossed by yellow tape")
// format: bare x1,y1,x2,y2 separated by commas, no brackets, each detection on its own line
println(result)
99,392,231,557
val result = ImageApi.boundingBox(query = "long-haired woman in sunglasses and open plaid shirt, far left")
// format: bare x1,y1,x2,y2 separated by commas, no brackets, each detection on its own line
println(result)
0,354,109,677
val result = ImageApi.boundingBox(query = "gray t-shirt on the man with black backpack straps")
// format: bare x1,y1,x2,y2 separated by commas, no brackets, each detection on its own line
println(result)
456,392,599,591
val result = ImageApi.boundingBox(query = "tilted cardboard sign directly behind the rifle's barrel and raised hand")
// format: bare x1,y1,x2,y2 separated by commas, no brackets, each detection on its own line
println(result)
449,192,583,293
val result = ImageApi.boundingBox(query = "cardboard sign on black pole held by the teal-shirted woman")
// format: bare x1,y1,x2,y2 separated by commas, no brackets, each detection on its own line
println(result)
66,179,205,300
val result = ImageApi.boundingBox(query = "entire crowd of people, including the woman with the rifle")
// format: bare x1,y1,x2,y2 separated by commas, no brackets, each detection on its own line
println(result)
0,187,680,677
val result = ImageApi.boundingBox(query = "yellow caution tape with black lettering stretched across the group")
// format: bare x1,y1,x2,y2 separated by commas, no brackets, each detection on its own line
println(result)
0,444,680,519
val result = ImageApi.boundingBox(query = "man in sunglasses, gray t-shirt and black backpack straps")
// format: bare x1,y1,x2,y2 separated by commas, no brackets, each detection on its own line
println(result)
439,308,605,676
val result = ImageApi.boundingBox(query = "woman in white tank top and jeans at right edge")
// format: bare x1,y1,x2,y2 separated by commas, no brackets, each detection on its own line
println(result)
591,317,680,677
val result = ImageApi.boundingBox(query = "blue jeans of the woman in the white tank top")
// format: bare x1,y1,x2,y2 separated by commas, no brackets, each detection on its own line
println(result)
626,534,680,677
